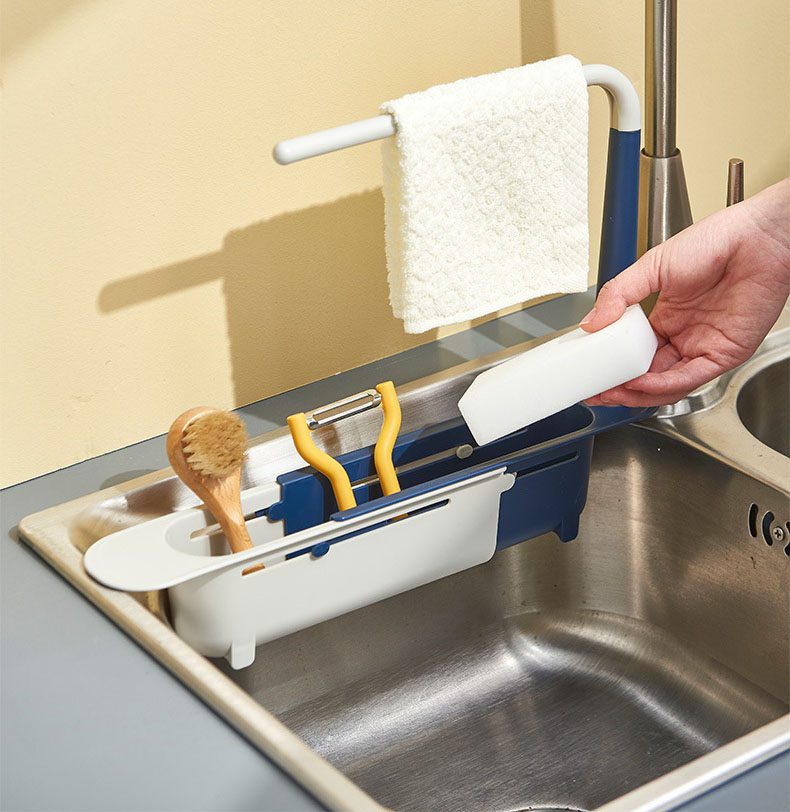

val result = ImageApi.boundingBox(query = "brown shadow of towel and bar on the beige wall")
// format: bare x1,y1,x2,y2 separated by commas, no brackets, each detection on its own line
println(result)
98,189,432,405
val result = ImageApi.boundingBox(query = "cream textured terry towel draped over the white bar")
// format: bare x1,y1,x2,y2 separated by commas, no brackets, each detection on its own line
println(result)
381,56,589,333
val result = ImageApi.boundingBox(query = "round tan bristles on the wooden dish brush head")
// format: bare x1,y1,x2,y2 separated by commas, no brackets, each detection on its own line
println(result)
181,412,247,477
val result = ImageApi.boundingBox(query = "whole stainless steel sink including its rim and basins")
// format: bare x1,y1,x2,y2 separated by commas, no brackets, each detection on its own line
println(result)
21,312,790,810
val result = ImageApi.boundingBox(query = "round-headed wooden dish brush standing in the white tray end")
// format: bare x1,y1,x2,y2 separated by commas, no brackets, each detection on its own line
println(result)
167,406,263,575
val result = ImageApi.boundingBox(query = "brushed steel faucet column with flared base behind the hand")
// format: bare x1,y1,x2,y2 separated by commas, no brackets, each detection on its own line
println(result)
637,0,693,256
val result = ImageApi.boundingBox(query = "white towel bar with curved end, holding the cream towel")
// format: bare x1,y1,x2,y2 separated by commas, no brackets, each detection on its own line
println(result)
273,65,642,164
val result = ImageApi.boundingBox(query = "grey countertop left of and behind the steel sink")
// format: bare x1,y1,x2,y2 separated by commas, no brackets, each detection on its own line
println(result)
0,291,593,812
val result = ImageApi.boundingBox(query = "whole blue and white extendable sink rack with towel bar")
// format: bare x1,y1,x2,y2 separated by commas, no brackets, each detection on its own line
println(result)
84,65,653,668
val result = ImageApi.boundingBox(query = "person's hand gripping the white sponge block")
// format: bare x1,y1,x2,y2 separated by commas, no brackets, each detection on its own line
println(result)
581,179,790,406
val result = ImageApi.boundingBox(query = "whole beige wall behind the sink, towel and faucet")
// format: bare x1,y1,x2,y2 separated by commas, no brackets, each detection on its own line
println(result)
0,0,790,485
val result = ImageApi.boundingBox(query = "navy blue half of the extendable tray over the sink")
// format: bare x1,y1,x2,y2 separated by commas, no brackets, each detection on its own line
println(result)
268,404,652,549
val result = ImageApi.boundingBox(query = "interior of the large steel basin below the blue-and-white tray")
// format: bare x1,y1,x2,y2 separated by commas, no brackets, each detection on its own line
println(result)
217,427,790,810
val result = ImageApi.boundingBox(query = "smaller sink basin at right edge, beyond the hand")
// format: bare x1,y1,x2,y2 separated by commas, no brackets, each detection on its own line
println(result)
738,358,790,457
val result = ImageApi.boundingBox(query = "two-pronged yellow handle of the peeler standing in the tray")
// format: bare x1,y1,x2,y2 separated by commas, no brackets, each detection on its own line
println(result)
288,381,401,510
